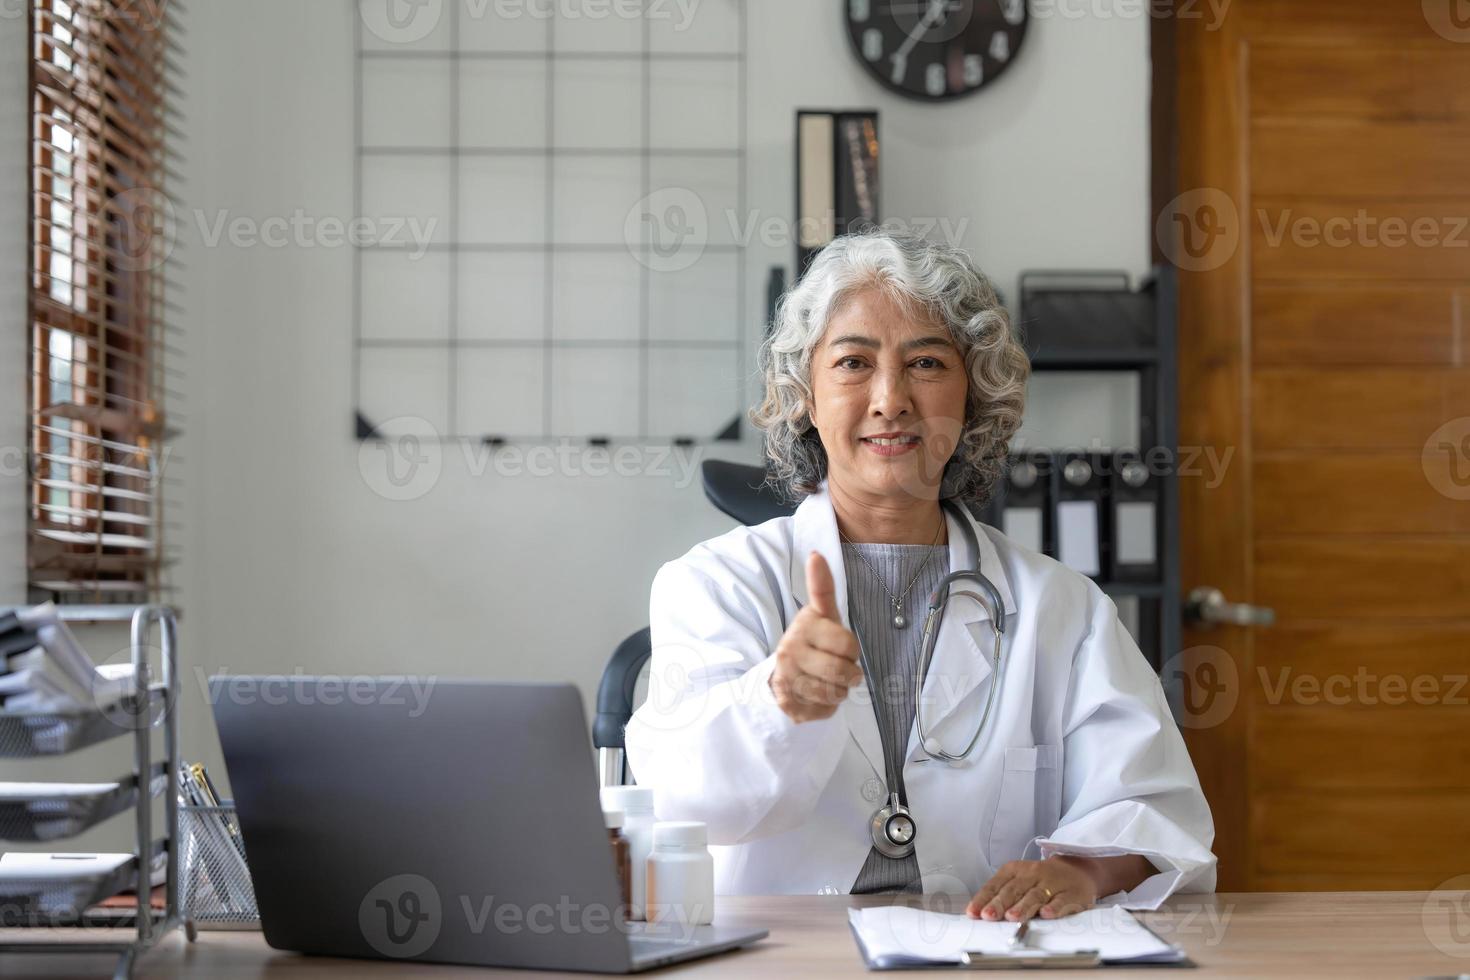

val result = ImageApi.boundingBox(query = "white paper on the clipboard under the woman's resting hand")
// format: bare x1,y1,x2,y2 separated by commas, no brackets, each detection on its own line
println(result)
848,905,1185,970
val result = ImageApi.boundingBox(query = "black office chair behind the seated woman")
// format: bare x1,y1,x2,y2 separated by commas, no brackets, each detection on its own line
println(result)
592,460,797,786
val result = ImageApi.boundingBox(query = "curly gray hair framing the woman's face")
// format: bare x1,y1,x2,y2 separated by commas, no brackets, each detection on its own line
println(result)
750,231,1030,504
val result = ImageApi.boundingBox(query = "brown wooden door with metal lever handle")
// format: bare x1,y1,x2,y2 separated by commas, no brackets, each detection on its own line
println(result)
1157,0,1470,890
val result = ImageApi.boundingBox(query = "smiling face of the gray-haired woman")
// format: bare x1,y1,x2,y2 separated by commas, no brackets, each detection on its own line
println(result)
810,289,969,501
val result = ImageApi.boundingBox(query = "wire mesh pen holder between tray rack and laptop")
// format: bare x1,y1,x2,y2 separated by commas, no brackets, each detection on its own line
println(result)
179,801,260,930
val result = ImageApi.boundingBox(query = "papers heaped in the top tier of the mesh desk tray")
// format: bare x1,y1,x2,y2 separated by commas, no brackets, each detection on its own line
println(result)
0,602,134,714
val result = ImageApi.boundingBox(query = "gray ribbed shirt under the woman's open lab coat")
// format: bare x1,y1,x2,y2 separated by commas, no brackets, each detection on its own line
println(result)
842,542,950,895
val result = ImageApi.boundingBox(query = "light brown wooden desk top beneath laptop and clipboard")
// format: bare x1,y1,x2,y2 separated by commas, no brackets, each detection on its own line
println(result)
0,892,1470,980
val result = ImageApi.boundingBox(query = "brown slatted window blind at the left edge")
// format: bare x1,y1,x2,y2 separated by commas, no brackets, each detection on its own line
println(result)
26,0,178,602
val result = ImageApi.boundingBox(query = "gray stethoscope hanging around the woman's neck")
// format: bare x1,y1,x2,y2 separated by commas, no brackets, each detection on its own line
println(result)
848,500,1005,858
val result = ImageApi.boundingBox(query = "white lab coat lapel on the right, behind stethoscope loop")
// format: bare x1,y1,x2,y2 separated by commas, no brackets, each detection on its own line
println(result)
904,505,1016,764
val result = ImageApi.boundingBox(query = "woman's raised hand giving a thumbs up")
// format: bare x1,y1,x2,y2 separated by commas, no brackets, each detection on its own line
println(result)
770,551,863,723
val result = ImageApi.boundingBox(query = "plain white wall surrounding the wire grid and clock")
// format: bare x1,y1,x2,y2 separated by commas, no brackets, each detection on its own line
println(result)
171,0,1148,781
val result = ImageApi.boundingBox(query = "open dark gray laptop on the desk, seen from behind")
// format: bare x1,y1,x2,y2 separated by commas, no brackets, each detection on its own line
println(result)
210,676,769,973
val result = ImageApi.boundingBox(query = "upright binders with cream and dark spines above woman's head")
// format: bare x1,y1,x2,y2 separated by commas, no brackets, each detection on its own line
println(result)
795,109,879,279
